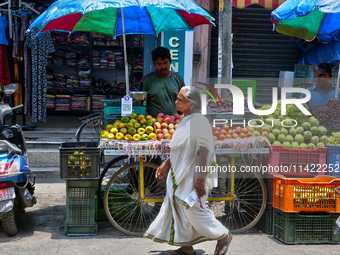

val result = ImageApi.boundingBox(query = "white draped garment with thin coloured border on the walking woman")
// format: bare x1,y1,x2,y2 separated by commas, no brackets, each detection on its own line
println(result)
144,113,229,246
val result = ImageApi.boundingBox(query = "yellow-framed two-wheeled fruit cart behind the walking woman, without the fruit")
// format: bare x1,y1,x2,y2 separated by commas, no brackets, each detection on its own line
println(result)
100,137,270,236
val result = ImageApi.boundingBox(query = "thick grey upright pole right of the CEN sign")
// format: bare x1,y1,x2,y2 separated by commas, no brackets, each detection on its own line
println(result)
218,0,232,98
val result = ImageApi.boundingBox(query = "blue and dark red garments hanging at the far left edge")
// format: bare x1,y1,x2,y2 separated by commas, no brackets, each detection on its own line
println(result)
0,16,11,86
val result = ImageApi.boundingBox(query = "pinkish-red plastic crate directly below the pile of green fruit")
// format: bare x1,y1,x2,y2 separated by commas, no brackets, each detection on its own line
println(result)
268,146,328,177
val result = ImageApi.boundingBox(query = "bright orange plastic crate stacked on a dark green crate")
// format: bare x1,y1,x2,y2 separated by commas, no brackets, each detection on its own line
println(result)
273,175,340,213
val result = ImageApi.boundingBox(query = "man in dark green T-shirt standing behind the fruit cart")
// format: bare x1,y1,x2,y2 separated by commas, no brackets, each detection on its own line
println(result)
141,47,184,118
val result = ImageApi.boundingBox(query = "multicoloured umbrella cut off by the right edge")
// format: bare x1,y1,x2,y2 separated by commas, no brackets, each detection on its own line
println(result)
272,0,340,98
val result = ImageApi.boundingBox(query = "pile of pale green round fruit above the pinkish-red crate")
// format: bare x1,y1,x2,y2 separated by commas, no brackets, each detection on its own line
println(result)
268,117,327,149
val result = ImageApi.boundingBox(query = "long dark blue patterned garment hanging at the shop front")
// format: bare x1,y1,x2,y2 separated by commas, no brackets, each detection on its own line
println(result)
25,27,55,123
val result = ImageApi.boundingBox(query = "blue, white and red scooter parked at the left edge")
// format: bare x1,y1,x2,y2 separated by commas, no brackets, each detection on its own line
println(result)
0,84,37,236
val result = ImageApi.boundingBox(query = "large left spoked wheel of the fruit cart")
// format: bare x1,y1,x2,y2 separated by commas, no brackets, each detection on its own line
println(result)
104,162,166,236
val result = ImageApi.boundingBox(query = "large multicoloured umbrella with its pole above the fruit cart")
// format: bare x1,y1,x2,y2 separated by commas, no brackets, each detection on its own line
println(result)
27,0,214,94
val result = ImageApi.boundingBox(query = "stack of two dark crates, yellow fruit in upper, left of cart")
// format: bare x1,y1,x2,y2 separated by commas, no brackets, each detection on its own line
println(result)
59,142,100,236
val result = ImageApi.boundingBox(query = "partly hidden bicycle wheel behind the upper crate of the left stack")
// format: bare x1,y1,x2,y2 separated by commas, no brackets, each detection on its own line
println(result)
75,115,102,142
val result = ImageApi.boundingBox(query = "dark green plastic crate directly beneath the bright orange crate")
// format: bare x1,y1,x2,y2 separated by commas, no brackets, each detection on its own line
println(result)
273,208,340,244
